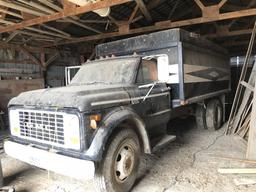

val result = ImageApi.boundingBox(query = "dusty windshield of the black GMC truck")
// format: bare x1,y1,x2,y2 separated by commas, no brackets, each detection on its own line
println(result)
70,57,139,85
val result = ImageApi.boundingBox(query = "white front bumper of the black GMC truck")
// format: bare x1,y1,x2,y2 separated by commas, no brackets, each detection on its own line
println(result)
4,141,95,180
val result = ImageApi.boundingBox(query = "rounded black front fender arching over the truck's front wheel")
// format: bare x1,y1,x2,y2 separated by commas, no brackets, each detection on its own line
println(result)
86,107,151,161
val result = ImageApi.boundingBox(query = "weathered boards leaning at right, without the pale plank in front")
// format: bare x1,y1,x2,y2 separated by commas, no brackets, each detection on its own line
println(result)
227,22,256,138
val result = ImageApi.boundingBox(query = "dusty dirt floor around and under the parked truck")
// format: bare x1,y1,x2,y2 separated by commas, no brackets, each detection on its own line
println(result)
1,119,256,192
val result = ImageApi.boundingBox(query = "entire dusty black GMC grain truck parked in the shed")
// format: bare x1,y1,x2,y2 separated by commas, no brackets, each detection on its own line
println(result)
4,29,230,192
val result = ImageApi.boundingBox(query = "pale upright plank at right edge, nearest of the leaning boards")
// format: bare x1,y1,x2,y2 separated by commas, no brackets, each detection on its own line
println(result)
246,86,256,160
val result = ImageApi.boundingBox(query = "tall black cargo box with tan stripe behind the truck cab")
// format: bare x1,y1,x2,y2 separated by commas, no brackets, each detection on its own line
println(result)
96,29,230,107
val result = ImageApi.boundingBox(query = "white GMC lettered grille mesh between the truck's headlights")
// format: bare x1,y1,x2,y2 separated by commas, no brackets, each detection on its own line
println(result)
19,111,65,145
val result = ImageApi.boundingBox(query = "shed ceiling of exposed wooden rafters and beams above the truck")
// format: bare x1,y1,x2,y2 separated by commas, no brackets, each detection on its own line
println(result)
0,0,256,53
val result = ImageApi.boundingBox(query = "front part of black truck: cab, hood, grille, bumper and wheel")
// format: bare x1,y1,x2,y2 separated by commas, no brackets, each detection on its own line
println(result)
5,55,174,191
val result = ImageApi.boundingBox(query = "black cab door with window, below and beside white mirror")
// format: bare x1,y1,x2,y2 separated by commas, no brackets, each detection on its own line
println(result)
136,57,170,128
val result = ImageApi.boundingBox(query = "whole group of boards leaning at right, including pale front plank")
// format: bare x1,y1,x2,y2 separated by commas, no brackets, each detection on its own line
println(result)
227,22,256,160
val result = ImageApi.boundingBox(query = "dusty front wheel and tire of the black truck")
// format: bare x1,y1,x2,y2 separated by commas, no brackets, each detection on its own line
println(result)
94,128,140,192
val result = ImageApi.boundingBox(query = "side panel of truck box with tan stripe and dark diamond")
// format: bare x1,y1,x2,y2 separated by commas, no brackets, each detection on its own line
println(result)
183,44,230,101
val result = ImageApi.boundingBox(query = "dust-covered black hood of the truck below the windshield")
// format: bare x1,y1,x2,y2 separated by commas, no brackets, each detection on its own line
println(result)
9,84,130,111
